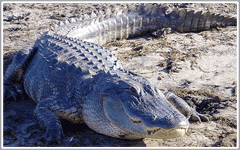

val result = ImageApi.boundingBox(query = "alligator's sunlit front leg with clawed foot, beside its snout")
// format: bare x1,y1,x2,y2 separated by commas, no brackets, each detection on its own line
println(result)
164,92,209,122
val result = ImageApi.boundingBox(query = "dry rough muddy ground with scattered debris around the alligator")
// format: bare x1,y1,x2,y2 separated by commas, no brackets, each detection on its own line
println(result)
3,3,237,147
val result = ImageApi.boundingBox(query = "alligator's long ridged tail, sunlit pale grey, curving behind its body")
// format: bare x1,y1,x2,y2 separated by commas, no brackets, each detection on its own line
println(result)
53,4,237,45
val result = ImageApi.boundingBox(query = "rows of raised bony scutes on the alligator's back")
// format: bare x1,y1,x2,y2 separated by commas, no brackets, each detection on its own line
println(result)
37,31,122,75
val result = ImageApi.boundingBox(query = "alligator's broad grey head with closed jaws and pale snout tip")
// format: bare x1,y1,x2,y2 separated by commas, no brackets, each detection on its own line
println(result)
83,70,189,139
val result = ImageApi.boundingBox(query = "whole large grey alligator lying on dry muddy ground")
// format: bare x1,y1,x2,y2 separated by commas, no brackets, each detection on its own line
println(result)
3,4,237,145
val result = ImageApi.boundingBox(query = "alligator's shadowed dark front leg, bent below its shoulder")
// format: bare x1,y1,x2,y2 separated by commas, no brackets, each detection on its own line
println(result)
34,99,63,145
